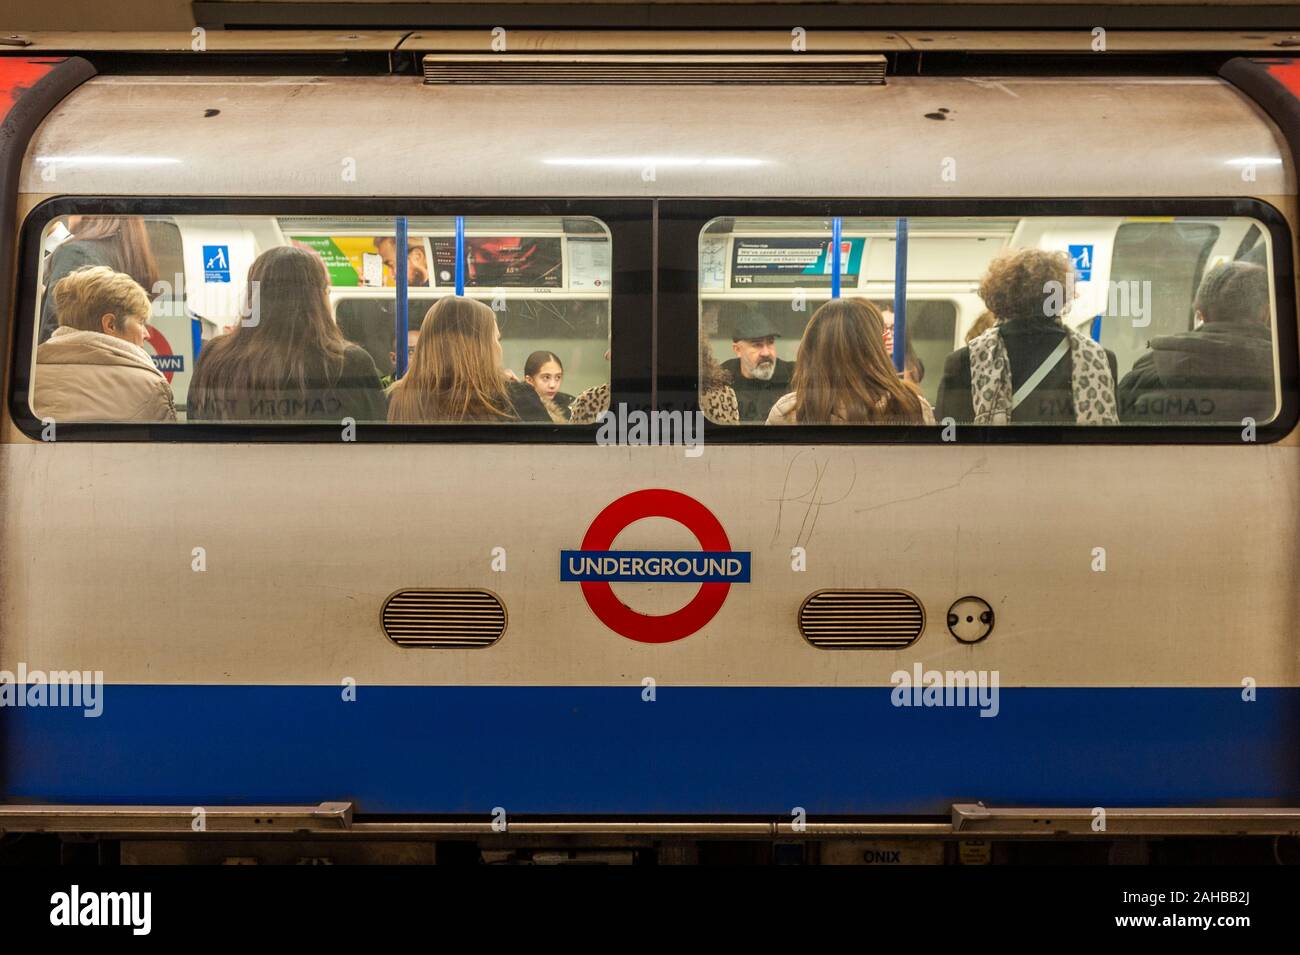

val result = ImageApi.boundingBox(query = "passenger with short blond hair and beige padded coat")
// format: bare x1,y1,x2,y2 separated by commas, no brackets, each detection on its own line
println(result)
34,265,176,424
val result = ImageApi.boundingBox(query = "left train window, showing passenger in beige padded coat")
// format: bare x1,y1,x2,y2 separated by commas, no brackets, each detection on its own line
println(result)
29,214,612,425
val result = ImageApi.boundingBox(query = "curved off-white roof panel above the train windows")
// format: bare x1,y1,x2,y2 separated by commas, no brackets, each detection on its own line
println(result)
20,74,1296,197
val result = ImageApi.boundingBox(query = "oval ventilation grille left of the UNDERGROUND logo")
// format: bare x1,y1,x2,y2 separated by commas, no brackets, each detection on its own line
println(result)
381,590,506,650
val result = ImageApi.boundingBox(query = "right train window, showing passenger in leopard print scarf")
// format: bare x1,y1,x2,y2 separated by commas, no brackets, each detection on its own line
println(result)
699,216,1281,426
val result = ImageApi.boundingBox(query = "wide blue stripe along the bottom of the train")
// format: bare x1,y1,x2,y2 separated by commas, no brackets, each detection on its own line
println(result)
0,685,1300,816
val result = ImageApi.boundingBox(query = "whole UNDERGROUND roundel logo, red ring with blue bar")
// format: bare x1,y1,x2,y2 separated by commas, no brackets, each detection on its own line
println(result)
560,489,749,643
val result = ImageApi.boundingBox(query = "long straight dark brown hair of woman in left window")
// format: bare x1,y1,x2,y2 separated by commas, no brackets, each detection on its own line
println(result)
190,246,348,418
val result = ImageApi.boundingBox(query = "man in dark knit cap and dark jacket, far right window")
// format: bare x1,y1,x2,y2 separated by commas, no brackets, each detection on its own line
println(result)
1119,261,1274,424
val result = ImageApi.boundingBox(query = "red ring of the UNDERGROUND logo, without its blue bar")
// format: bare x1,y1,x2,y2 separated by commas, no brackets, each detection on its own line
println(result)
581,487,731,643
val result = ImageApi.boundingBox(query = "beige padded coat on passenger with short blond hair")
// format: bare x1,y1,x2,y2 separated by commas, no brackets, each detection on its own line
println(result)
33,326,176,422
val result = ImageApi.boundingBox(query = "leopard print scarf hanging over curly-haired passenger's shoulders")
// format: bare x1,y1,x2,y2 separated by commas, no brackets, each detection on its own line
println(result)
970,321,1119,425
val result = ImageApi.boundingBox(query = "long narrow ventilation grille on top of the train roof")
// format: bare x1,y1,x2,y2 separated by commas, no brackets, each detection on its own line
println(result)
424,53,885,86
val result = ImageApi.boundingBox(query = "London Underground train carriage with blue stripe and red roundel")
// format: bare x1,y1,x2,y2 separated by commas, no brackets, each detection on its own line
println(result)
0,32,1300,861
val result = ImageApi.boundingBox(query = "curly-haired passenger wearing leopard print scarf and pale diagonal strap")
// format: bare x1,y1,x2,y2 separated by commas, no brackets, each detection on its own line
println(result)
937,248,1119,425
